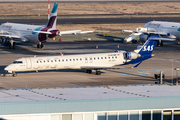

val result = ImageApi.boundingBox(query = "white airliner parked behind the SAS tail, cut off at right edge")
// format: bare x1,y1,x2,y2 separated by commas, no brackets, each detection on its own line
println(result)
122,21,180,45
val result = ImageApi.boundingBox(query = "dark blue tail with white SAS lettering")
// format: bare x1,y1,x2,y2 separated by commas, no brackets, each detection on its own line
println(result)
125,36,160,67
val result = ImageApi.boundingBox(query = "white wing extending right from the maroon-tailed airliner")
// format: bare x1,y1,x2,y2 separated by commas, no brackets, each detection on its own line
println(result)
59,30,96,36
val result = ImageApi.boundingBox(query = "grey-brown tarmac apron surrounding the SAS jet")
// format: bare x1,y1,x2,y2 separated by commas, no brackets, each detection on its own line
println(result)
0,37,180,88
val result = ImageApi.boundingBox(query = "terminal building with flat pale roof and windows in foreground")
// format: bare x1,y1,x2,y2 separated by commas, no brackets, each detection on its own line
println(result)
0,84,180,120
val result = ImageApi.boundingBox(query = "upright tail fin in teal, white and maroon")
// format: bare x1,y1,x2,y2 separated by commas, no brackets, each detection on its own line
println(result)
46,3,58,29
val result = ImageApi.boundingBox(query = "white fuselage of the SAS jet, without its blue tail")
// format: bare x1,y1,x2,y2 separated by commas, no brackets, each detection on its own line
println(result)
5,51,125,72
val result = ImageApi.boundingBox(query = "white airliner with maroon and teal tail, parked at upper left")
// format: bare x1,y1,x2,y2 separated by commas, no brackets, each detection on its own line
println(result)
0,3,94,49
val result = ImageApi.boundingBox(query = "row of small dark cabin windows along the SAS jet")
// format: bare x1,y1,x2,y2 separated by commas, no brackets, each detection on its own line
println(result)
37,56,117,63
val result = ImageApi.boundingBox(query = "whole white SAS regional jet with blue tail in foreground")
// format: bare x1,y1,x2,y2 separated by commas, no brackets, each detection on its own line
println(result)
4,37,159,76
